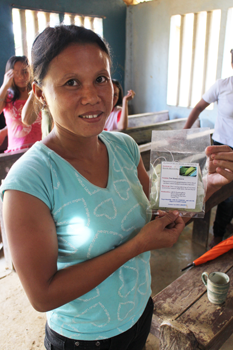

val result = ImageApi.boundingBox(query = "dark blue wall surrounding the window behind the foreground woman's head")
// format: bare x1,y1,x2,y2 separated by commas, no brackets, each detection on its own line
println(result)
0,0,126,90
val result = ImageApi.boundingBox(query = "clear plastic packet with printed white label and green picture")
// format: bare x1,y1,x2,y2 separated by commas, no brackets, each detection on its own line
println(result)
147,128,210,218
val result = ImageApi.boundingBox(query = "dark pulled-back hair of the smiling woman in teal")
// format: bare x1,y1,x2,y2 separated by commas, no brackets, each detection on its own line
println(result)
32,24,111,85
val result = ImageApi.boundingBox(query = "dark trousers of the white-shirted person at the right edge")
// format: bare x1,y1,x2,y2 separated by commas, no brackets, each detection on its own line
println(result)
213,141,233,237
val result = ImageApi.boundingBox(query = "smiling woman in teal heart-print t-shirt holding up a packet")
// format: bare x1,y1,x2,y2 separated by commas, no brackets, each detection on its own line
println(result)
1,25,233,350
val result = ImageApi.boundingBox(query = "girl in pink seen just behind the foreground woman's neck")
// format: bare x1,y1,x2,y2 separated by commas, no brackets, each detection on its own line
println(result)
104,79,135,131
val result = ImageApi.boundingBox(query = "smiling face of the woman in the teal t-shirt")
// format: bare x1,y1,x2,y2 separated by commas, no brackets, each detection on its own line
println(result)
37,44,113,137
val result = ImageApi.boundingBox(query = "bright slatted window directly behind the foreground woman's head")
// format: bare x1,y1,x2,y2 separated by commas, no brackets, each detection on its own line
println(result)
12,8,103,60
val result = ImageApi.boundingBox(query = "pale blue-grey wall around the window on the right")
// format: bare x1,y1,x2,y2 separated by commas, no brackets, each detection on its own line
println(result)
125,0,233,127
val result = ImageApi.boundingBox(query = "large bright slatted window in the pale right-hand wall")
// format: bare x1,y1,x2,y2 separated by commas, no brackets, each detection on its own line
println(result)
167,10,221,108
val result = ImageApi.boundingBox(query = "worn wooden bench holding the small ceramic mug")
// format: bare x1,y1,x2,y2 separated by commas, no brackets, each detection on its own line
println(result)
151,250,233,350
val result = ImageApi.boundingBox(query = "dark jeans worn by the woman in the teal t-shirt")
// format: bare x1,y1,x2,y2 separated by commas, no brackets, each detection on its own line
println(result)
44,298,154,350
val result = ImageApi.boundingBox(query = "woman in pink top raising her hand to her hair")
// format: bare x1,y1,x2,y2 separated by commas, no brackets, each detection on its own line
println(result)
0,56,41,152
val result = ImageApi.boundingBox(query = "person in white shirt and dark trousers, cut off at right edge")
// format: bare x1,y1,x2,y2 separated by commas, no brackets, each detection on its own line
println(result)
184,50,233,248
